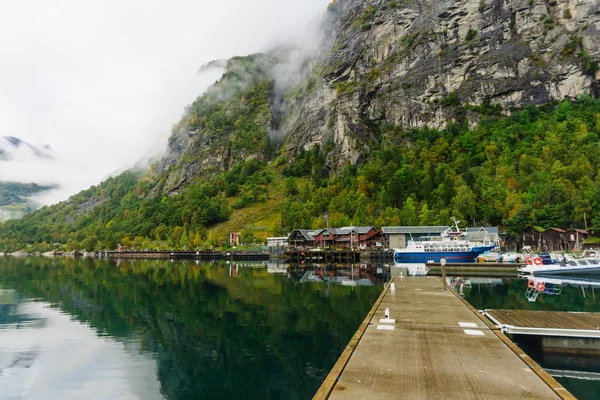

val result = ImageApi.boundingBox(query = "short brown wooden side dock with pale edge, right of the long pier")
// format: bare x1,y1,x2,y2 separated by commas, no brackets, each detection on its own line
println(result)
484,310,600,339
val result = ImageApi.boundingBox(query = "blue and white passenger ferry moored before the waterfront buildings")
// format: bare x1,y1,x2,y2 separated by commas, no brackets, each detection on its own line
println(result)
394,218,497,264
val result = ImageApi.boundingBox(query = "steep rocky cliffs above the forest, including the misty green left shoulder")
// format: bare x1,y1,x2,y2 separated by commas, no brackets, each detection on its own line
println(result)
157,0,600,189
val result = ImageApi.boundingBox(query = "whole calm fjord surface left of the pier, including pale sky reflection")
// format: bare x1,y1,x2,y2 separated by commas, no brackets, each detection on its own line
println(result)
0,257,384,399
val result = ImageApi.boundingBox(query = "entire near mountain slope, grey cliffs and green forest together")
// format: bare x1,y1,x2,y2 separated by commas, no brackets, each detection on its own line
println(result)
0,0,600,250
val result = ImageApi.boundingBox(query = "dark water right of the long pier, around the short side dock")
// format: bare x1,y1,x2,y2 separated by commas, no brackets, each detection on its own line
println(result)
451,278,600,400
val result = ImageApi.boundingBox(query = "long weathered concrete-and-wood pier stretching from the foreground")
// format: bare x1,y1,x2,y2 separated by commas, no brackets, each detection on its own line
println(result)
315,277,574,400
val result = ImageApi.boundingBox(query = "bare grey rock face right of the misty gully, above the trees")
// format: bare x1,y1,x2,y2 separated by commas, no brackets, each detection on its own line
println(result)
285,0,600,170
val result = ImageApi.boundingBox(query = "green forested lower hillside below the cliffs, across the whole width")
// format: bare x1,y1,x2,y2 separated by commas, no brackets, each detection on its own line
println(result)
0,95,600,251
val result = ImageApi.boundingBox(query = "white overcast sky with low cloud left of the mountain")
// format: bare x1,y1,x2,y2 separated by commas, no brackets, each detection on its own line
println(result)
0,0,329,202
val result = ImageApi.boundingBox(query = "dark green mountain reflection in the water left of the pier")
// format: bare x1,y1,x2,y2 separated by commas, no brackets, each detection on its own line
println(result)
0,257,383,399
